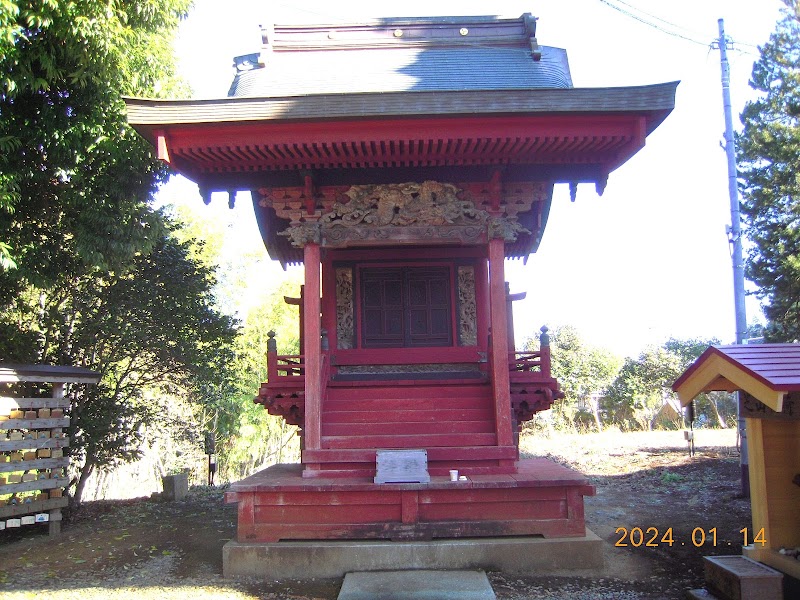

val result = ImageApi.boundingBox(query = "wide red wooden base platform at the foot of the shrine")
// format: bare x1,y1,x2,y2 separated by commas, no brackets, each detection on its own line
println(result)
225,458,595,543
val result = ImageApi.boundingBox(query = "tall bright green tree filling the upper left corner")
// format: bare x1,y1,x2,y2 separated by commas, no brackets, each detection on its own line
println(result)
0,0,189,278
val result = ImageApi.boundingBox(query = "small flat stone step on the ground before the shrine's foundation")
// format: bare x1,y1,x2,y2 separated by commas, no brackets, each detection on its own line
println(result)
338,570,497,600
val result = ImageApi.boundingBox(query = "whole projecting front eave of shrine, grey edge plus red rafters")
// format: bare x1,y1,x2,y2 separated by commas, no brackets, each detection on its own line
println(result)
126,83,677,189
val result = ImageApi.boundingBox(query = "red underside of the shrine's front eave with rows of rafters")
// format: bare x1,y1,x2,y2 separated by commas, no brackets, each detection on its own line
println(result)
145,115,646,182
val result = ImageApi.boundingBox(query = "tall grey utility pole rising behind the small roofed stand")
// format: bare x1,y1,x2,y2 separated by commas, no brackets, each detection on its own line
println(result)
717,19,750,498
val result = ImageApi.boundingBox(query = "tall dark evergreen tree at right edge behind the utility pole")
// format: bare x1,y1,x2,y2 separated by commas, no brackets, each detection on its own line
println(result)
737,0,800,341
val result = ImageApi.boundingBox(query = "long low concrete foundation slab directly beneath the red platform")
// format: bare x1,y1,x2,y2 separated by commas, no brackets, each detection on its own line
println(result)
222,529,603,580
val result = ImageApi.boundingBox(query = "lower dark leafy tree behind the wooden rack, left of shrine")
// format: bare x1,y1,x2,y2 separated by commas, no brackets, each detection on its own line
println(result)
0,223,235,503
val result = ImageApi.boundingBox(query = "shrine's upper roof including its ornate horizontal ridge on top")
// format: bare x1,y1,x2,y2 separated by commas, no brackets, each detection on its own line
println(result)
228,14,572,98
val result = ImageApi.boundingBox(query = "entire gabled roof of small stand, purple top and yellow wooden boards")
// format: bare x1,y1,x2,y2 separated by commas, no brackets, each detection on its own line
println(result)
672,344,800,412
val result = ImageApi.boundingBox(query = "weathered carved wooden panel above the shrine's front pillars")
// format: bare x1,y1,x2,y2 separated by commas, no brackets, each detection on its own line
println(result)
272,181,540,248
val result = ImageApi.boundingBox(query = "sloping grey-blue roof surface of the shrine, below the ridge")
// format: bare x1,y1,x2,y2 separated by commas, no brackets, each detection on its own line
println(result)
228,45,572,98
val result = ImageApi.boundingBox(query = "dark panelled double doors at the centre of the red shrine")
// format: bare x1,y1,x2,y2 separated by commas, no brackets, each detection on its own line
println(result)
359,267,453,348
